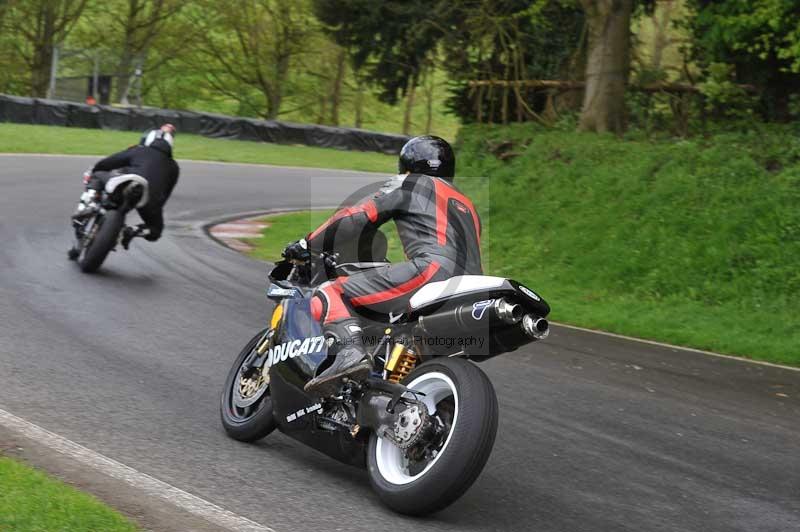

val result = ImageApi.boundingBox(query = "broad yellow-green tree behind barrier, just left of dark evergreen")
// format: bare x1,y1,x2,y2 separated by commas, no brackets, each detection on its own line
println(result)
195,0,315,119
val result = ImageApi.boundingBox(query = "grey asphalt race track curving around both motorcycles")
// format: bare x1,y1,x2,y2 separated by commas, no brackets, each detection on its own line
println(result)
0,156,800,532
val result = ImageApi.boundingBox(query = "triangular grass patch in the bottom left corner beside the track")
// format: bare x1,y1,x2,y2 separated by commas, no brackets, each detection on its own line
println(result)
0,457,138,532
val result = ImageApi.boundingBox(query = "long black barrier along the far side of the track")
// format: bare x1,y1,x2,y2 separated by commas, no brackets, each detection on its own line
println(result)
0,94,408,154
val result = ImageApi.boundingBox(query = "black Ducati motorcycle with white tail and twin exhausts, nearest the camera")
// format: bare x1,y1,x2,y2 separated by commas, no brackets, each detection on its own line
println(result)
221,248,550,515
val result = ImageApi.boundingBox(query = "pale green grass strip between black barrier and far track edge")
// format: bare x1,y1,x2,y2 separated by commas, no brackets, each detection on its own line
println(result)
0,123,397,173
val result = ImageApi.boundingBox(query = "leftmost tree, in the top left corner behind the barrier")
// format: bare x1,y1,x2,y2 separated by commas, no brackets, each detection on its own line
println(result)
5,0,87,98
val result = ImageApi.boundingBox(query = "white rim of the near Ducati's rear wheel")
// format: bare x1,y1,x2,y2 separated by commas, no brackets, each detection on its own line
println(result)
375,372,458,485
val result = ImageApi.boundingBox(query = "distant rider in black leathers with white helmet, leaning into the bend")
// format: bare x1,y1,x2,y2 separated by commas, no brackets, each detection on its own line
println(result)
76,124,180,249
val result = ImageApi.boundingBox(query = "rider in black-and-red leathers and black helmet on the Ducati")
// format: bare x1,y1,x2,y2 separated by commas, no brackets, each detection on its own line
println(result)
284,136,482,397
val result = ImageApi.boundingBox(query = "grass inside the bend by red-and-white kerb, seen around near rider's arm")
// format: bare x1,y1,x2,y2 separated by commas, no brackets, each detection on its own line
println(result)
246,210,405,262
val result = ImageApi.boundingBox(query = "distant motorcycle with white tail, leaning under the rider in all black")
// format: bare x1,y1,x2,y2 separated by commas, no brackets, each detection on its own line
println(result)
68,172,148,273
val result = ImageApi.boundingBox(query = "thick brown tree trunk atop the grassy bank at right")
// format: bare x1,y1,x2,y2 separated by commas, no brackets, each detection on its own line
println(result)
578,0,633,133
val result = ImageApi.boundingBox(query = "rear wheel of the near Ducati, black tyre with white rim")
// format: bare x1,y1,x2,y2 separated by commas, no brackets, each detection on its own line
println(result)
367,358,498,515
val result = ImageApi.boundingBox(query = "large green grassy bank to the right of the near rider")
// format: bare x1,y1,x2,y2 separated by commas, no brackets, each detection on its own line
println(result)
457,126,800,365
